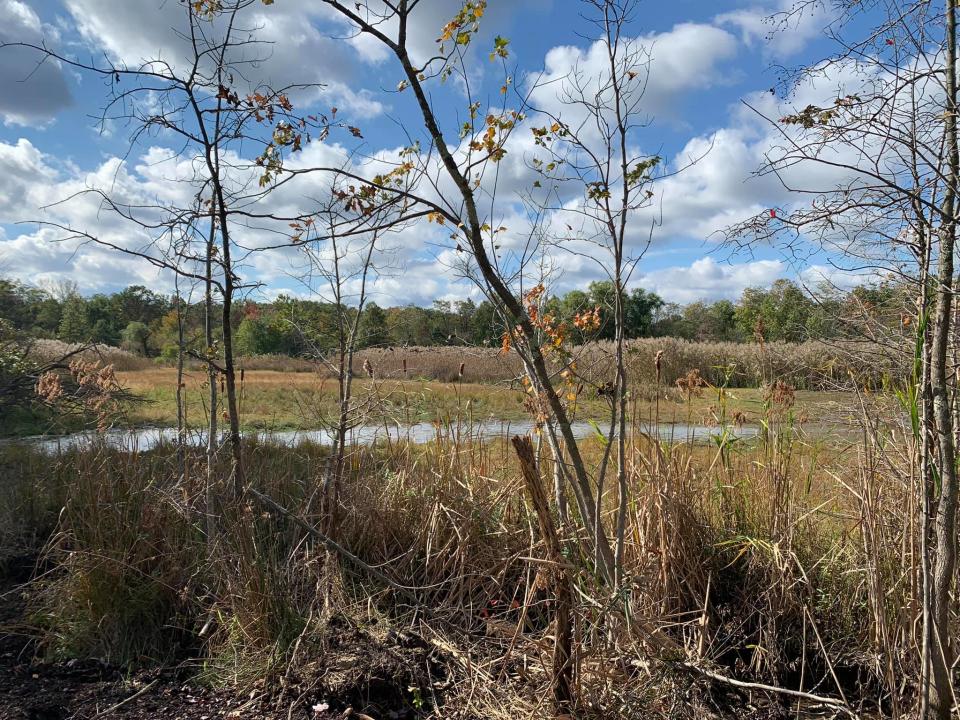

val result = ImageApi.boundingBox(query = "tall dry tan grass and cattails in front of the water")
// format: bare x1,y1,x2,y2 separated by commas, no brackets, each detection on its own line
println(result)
4,382,918,718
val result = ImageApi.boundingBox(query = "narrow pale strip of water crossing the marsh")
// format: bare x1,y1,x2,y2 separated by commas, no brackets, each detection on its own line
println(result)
9,420,758,454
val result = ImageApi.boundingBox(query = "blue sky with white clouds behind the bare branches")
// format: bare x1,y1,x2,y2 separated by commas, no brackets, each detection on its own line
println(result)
0,0,856,305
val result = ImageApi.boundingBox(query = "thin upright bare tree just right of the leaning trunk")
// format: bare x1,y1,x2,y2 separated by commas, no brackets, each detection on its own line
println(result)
531,0,661,583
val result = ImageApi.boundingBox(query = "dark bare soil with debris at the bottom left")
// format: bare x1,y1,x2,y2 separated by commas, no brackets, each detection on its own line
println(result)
0,558,442,720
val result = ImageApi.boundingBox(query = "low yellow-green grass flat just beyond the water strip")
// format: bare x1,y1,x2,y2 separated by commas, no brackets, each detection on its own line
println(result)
110,368,854,430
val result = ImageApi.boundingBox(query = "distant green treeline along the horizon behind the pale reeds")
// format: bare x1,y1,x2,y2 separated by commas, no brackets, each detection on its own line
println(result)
0,279,908,358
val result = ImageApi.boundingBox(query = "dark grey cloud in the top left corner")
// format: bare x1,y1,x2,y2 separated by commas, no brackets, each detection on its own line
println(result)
0,0,72,125
